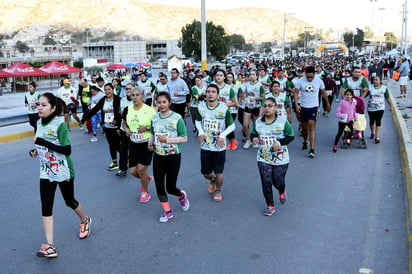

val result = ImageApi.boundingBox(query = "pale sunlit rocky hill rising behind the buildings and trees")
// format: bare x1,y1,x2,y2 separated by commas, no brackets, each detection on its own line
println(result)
0,0,310,43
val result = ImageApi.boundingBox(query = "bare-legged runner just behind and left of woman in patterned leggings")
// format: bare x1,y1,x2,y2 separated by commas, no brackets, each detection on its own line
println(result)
240,69,265,149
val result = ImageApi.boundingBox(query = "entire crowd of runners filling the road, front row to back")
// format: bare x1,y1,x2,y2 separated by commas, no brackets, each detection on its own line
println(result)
25,52,412,258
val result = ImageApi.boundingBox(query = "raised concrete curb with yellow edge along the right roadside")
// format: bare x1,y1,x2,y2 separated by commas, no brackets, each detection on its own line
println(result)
390,94,412,273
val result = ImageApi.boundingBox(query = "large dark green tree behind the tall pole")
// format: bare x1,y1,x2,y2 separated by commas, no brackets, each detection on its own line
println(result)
182,20,229,60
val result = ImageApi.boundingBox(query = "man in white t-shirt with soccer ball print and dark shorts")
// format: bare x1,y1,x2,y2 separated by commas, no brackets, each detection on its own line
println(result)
294,66,330,158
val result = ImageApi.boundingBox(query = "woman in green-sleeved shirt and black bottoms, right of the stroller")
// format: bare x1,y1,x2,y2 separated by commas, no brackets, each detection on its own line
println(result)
368,76,393,144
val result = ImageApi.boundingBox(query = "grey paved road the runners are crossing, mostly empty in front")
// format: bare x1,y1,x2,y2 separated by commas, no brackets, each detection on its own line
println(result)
0,101,408,274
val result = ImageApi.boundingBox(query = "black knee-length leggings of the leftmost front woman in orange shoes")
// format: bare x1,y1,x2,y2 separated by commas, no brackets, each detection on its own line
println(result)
40,178,79,217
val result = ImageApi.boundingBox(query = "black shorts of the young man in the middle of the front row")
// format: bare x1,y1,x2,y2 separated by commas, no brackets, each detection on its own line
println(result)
200,149,226,174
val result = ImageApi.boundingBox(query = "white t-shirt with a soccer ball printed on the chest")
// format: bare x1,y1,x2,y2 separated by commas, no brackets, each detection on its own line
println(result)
295,76,325,108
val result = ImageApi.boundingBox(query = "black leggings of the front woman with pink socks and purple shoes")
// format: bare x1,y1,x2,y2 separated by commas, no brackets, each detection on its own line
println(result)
153,153,182,203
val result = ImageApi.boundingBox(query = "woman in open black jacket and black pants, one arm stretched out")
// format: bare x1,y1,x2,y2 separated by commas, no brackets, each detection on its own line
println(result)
82,83,121,170
